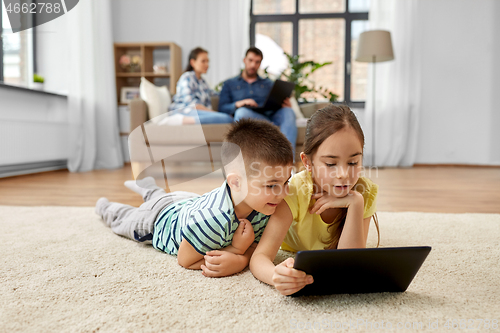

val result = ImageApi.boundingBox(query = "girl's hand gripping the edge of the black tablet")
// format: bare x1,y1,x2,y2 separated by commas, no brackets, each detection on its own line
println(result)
273,258,314,295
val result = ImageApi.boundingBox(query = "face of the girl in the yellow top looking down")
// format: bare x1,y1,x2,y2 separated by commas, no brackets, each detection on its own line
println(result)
300,126,363,198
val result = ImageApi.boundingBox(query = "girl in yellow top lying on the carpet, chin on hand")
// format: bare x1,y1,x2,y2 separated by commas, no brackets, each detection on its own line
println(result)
250,105,378,295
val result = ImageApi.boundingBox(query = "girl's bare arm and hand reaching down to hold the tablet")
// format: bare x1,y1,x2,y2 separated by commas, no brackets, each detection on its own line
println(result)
250,200,312,295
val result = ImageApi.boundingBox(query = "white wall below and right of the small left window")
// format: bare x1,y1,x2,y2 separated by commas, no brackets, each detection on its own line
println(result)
0,12,70,175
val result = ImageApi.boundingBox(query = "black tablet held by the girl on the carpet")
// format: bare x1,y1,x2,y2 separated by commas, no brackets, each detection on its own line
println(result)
291,246,431,296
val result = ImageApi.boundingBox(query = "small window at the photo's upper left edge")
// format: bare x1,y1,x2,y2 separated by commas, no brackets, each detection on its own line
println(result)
0,1,35,87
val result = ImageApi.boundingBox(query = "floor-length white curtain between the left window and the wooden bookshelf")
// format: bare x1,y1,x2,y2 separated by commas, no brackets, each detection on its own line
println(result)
66,0,123,172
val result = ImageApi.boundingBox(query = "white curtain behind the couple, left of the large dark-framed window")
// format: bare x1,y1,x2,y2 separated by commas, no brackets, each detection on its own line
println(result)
178,0,250,87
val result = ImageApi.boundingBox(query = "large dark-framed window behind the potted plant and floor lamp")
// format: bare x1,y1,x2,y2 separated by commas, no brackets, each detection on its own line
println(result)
250,0,370,107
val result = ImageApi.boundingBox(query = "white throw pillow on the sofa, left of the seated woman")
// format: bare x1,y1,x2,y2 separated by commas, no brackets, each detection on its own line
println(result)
139,77,172,123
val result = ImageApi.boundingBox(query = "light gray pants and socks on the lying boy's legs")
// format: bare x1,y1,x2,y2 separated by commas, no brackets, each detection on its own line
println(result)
95,187,199,243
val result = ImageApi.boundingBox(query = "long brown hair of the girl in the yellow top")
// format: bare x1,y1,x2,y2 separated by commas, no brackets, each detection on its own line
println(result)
303,104,380,249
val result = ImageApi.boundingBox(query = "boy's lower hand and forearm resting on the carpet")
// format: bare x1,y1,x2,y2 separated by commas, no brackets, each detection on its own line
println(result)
201,250,248,277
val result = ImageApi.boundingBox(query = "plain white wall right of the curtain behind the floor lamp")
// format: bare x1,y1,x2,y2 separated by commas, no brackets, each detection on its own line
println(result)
412,0,500,165
